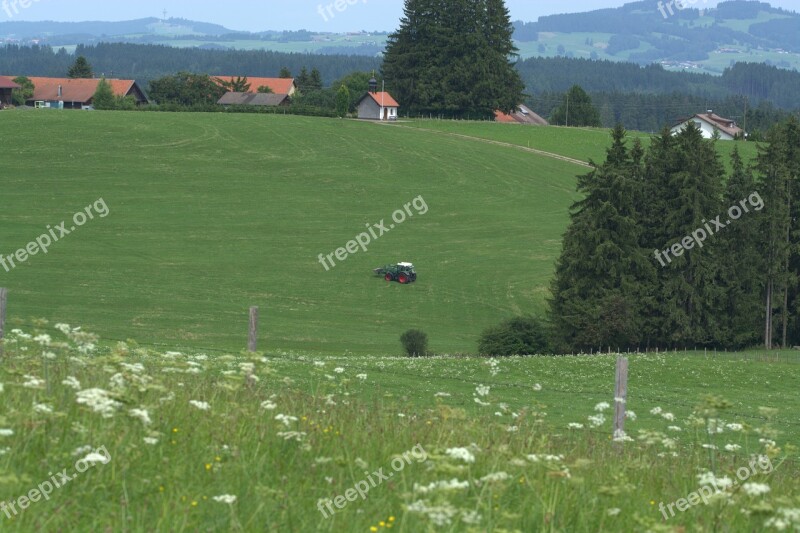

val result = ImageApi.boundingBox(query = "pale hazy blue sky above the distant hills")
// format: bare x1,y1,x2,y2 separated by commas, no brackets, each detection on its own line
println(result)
0,0,798,32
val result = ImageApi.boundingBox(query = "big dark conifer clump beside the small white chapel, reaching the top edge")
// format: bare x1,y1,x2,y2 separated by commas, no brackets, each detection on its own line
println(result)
382,0,524,118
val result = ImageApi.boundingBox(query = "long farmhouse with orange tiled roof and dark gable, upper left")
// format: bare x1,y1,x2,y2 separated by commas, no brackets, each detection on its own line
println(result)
18,77,149,109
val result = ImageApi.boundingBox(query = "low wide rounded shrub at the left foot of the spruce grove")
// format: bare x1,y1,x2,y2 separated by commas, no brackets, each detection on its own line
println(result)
478,317,550,357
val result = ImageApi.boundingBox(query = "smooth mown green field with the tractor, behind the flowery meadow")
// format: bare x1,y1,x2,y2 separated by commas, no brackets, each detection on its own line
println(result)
0,112,754,355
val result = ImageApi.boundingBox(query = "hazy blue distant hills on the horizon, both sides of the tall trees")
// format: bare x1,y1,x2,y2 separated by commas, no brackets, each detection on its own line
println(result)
0,0,800,75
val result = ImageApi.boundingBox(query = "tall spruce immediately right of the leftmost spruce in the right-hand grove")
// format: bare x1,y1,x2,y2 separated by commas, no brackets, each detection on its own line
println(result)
647,123,725,348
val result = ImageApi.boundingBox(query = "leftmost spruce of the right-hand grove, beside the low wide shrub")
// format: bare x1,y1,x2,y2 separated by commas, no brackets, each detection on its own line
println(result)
550,126,656,352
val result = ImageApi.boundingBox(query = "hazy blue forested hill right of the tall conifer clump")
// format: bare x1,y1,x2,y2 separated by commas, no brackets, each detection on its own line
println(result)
514,0,800,73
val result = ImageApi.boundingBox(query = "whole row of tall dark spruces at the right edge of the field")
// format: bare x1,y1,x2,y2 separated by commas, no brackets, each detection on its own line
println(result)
550,119,800,352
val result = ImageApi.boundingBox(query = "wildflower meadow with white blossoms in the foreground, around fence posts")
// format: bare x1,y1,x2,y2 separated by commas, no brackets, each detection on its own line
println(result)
0,325,800,533
